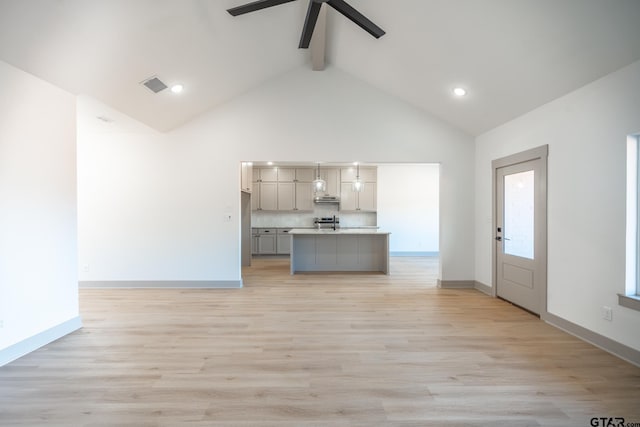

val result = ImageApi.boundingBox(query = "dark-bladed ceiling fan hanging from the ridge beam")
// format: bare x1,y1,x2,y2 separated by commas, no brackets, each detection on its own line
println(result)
227,0,385,49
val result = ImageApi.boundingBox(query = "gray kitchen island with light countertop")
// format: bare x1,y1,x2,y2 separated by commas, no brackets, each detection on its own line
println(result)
289,228,390,274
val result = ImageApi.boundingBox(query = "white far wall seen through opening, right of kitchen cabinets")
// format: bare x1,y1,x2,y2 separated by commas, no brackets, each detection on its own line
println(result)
378,164,440,252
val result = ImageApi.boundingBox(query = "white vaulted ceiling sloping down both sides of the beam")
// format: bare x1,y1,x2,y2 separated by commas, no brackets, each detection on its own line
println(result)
0,0,640,135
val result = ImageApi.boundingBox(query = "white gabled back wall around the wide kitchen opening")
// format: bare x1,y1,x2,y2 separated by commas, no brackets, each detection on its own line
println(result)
78,68,474,281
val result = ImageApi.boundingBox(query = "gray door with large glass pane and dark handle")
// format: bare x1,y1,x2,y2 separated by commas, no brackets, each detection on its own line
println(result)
495,152,547,315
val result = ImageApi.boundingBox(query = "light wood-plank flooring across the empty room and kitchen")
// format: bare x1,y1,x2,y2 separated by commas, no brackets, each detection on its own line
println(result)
0,258,640,427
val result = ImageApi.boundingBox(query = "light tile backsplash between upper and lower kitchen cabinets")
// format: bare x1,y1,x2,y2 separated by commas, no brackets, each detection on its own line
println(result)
251,204,378,228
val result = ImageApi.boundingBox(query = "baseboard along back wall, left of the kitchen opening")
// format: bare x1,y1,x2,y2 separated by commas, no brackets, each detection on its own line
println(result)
78,280,242,289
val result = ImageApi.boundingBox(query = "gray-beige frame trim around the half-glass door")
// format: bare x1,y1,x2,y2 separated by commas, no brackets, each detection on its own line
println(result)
491,145,549,320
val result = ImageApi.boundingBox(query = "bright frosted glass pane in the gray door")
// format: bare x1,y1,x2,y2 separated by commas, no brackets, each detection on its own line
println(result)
502,170,534,259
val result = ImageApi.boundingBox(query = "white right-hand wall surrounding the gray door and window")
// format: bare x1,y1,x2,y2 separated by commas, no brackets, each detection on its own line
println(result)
475,62,640,350
